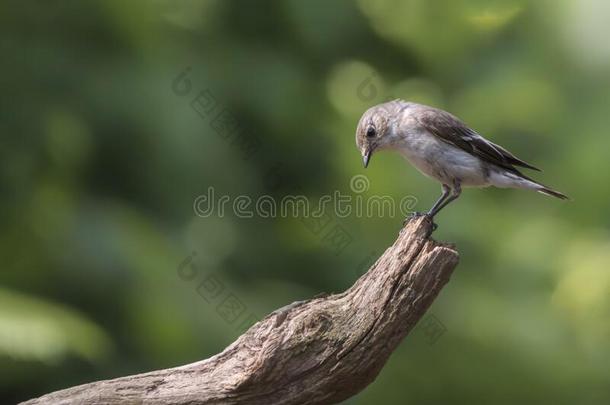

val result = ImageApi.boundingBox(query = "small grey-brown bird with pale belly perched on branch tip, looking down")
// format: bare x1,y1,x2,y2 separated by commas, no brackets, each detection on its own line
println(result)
356,100,568,218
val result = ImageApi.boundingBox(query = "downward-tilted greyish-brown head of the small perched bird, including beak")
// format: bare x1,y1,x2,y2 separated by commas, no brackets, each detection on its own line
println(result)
356,104,391,167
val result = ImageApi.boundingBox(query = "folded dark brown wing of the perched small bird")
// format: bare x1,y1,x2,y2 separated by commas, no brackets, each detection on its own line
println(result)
417,108,540,172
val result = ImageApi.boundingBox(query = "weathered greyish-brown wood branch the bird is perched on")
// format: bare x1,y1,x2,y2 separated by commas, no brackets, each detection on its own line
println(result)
26,217,458,405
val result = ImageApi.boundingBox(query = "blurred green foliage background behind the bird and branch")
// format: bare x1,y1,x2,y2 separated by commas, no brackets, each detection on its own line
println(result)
0,0,610,404
